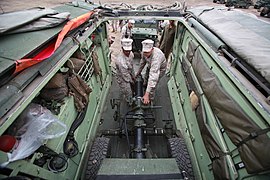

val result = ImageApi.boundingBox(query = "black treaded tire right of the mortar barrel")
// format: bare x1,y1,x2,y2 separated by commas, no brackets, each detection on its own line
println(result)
168,138,195,179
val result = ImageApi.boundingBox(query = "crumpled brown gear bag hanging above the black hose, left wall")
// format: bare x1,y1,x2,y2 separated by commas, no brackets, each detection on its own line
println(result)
68,74,92,112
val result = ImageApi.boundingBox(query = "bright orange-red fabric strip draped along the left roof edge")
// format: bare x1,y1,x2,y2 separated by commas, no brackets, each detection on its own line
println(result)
14,11,94,74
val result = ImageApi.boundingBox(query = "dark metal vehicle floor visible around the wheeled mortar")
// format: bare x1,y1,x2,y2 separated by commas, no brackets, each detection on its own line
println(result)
98,59,175,158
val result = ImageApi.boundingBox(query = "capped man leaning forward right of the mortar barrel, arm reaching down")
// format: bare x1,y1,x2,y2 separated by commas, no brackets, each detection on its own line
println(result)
136,39,167,104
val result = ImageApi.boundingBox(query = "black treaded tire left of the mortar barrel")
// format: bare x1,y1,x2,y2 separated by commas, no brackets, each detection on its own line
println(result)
85,137,110,180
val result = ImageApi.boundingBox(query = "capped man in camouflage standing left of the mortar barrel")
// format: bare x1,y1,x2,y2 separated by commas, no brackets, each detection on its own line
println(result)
115,39,135,101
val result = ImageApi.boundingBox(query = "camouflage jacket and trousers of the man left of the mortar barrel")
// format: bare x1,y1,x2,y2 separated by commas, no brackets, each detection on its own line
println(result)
115,51,135,100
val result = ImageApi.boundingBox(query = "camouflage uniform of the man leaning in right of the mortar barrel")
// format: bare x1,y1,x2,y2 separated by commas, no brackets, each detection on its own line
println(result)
140,47,167,99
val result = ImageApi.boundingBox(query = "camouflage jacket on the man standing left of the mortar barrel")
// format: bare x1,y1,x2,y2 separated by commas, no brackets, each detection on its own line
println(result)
115,51,135,83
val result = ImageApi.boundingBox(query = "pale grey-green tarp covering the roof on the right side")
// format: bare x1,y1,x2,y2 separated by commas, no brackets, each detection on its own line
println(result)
189,7,270,82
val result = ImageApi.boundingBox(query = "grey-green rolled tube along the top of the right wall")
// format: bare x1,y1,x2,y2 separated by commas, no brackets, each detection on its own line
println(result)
188,18,226,51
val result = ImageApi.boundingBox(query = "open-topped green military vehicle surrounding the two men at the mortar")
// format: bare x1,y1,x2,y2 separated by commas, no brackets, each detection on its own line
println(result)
0,1,270,180
